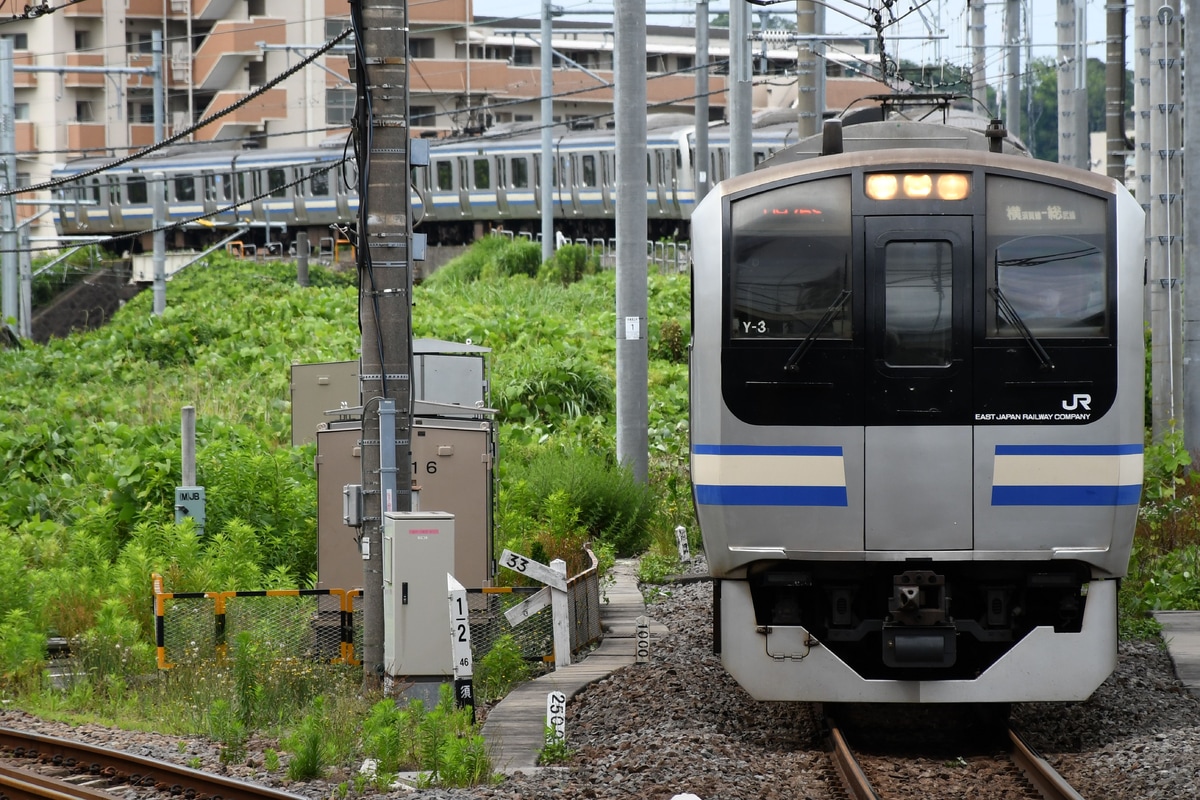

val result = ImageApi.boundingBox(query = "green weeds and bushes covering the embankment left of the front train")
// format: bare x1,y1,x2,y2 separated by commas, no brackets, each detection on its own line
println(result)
0,240,691,793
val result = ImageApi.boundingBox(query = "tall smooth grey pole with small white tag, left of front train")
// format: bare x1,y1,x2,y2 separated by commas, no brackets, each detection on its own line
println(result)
613,0,649,483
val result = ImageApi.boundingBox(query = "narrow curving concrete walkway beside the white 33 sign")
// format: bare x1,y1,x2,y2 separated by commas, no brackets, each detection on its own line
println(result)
484,560,666,774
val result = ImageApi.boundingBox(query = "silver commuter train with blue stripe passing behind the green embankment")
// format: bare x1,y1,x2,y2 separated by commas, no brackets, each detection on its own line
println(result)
53,115,796,248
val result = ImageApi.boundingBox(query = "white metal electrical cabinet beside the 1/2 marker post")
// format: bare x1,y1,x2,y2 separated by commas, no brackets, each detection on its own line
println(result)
383,511,454,678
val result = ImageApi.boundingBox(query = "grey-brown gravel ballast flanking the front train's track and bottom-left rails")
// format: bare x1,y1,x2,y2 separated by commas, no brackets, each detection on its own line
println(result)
0,566,1200,800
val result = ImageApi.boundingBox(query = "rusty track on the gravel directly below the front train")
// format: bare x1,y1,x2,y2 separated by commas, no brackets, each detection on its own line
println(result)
826,718,1084,800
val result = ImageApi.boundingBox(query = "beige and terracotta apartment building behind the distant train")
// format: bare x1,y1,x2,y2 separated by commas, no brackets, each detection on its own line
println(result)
9,0,883,241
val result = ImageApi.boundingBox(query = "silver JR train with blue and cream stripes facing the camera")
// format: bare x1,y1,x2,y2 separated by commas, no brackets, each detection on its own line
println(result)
690,103,1145,709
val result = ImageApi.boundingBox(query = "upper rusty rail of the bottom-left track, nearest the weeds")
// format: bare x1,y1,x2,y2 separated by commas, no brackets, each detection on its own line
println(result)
0,728,305,800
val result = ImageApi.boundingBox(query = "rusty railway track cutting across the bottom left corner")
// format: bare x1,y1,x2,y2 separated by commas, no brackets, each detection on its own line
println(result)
0,728,304,800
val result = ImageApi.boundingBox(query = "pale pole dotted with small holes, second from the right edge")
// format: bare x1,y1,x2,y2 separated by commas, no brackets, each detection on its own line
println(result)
1146,0,1183,440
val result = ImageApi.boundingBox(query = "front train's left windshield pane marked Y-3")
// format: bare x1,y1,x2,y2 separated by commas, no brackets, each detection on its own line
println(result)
728,178,852,339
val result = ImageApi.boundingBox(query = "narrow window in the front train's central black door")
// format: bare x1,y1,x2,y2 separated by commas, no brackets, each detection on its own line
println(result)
883,241,954,367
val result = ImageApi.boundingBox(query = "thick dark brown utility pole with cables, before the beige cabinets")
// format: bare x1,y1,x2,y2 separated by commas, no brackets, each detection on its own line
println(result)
350,0,413,687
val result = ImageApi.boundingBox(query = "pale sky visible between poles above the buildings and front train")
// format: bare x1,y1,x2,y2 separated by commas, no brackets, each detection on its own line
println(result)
474,0,1133,84
